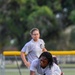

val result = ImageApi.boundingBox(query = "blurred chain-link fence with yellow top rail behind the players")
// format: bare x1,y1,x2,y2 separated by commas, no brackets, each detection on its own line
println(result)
0,51,75,75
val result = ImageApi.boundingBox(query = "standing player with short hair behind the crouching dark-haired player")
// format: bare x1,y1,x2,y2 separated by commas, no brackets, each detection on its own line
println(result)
21,28,47,68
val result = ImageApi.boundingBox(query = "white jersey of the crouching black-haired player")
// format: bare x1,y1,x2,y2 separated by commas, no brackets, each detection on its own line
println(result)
30,59,61,75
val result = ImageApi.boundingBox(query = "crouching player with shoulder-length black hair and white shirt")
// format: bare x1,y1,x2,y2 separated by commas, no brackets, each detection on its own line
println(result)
30,52,61,75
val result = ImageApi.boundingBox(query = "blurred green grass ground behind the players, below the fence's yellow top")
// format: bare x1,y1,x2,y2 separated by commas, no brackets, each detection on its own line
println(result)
0,64,75,75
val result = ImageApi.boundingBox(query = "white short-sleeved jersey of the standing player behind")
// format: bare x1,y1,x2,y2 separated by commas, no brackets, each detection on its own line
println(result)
21,39,45,63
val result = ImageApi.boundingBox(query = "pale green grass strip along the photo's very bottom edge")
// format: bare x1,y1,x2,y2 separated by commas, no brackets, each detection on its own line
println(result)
4,68,75,75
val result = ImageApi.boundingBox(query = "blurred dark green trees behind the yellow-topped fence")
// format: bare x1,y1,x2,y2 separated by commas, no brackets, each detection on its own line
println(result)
0,0,75,75
